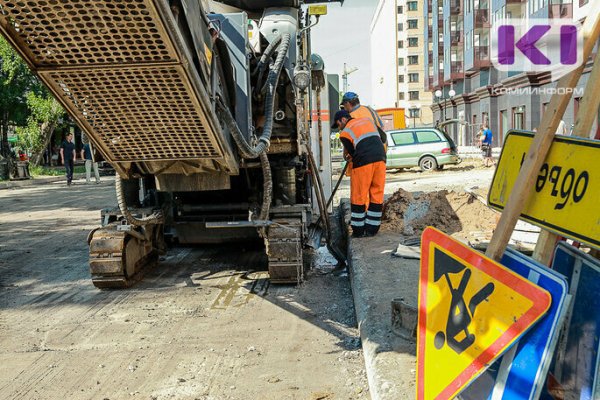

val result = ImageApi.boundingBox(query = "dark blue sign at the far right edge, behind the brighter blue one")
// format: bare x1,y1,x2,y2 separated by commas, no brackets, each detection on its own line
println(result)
542,243,600,400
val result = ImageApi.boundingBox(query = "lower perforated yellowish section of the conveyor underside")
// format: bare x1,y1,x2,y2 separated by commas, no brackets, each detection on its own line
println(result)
47,66,219,161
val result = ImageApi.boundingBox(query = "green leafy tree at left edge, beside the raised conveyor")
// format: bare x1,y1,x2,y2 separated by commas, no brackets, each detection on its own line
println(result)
0,37,65,164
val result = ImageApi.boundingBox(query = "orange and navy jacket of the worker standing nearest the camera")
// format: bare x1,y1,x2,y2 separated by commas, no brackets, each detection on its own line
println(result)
340,118,386,168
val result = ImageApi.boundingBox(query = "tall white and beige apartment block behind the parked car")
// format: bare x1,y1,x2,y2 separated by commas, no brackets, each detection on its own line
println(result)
371,0,434,126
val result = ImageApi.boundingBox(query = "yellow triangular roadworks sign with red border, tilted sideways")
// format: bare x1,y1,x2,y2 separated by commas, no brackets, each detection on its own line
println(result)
417,228,551,400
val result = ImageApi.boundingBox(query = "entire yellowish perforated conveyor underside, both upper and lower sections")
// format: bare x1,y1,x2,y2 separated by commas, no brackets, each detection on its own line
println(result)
0,0,235,168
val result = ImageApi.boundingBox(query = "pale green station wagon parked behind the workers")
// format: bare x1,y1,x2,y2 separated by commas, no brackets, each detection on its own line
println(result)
387,128,462,171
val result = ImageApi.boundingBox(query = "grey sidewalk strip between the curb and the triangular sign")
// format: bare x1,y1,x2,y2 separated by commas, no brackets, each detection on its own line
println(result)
341,202,419,400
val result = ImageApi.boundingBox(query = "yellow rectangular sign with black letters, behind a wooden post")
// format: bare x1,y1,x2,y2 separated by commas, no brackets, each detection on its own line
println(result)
488,131,600,247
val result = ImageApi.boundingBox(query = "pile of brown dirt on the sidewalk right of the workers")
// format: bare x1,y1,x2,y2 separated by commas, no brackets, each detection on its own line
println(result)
382,189,498,238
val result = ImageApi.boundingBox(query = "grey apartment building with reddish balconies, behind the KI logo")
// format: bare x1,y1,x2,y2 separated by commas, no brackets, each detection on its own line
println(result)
424,0,598,146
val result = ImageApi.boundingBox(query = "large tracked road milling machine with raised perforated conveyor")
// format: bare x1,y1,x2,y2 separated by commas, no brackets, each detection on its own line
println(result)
0,0,343,288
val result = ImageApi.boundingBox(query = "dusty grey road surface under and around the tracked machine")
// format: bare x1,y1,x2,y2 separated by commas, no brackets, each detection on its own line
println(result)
0,179,369,400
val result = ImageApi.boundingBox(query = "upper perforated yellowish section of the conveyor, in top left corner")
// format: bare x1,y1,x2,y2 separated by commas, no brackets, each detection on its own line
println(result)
0,0,177,66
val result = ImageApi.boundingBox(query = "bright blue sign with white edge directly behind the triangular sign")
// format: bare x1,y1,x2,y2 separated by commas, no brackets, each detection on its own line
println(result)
458,249,568,400
